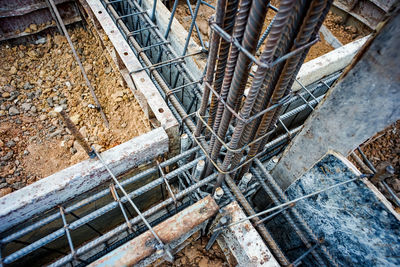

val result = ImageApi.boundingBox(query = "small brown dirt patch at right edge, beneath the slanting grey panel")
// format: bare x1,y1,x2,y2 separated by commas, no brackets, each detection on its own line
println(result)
361,120,400,207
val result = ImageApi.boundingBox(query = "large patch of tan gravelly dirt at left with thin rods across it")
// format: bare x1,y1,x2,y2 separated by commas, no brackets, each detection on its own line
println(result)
0,27,150,197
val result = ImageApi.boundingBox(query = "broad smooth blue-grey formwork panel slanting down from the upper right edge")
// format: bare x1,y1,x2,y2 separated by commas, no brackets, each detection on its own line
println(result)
272,9,400,192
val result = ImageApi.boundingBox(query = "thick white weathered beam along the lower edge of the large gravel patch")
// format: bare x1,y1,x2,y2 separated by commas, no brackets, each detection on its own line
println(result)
0,127,168,232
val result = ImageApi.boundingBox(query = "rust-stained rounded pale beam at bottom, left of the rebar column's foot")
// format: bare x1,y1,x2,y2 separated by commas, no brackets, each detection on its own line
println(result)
89,196,219,267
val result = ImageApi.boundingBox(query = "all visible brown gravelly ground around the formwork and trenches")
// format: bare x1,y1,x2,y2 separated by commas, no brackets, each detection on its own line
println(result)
0,1,400,266
